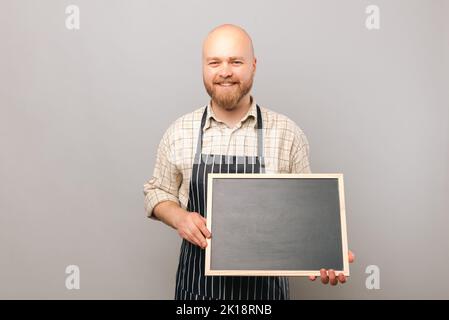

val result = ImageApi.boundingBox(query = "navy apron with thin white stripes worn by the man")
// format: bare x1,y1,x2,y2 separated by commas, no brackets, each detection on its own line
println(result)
175,106,289,300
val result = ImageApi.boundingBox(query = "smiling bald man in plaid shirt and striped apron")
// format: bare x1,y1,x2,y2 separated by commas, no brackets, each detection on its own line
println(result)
144,25,353,299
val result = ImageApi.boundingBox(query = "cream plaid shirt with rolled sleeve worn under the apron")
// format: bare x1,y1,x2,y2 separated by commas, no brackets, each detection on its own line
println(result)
143,97,311,218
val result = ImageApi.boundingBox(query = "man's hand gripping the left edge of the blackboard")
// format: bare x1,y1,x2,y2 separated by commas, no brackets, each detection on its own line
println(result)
175,211,211,249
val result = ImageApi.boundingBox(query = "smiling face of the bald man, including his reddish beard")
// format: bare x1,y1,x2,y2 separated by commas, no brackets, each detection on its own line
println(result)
203,32,256,110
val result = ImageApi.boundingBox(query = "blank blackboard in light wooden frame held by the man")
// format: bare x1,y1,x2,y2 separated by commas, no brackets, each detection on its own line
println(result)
205,173,349,276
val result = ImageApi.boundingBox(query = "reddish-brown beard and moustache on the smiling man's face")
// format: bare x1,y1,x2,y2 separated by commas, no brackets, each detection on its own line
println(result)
203,75,254,110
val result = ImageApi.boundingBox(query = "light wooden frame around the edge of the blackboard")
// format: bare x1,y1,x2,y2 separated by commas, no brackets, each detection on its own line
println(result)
205,173,350,276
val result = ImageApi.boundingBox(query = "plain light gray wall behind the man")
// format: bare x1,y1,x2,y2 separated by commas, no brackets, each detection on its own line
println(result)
0,0,449,299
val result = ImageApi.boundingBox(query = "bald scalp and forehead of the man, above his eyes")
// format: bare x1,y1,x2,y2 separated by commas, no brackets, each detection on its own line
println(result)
203,24,254,59
